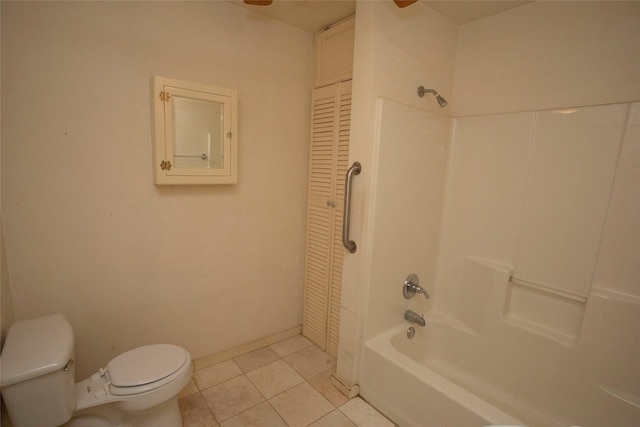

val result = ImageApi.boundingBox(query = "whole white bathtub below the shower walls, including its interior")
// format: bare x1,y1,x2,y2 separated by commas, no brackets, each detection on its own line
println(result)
358,291,640,427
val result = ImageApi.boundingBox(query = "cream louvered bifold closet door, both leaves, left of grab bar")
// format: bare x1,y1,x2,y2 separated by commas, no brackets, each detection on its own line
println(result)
303,82,351,356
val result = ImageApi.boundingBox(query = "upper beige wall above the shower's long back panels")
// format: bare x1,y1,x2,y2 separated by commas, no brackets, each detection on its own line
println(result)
452,1,640,117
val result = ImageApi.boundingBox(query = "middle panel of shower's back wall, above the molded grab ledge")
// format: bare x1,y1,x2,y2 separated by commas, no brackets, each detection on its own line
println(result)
515,104,628,298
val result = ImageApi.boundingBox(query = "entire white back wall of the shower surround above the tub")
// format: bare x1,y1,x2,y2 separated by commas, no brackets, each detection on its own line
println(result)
434,103,640,345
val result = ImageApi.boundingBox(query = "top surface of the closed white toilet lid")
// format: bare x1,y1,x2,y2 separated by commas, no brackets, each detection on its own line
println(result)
107,344,187,387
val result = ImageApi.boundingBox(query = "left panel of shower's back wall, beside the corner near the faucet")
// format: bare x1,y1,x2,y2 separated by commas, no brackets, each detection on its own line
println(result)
433,113,535,313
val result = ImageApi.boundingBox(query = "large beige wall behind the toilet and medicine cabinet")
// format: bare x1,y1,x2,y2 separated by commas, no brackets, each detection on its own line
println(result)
2,2,312,376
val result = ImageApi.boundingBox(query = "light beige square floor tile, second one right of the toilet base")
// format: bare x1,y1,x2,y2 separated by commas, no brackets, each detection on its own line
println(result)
201,375,264,422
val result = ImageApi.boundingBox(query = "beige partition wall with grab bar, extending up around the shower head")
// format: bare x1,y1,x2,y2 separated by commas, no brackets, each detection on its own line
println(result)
337,2,456,385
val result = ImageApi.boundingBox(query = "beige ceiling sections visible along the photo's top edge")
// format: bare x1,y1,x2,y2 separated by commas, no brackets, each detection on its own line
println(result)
227,0,530,32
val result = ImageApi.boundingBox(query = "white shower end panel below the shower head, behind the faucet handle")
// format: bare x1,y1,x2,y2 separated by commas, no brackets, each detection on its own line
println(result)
366,99,451,342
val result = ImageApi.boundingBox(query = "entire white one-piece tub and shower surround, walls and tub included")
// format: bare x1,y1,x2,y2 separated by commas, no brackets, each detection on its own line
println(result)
359,101,640,427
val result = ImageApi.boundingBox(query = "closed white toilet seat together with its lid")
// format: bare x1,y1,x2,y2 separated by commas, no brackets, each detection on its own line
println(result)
106,344,190,396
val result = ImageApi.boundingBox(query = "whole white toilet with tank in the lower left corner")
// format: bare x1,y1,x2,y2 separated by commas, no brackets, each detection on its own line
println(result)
0,314,192,427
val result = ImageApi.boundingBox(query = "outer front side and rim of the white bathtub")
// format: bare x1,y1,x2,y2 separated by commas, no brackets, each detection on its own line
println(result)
359,320,524,427
